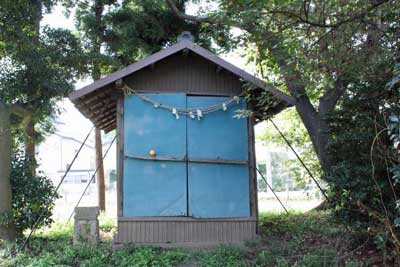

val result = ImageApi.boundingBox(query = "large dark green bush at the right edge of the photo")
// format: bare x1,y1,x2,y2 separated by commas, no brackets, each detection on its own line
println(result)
326,64,400,256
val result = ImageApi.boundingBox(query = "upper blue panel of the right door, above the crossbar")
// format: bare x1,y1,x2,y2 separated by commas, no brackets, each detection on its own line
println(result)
187,96,248,160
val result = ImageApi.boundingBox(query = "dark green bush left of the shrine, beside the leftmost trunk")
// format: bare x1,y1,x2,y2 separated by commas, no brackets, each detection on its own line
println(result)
11,150,58,238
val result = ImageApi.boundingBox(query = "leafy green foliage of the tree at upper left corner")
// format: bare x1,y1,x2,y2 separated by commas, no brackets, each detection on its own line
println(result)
0,0,83,163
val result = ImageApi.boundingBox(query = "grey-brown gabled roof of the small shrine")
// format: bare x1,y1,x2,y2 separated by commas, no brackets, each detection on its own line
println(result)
69,39,294,131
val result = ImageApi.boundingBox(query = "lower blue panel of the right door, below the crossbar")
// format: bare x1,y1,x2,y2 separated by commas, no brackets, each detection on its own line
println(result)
188,163,250,218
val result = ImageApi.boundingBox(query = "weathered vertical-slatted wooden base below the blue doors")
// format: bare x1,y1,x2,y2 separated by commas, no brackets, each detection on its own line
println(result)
114,217,257,244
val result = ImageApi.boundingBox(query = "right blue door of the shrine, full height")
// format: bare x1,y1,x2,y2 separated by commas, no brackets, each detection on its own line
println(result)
187,96,250,218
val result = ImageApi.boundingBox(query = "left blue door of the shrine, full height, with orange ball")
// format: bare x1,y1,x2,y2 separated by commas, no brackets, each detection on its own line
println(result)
123,94,187,216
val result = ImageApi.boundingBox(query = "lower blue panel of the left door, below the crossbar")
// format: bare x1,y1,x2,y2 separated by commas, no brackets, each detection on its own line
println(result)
123,159,187,216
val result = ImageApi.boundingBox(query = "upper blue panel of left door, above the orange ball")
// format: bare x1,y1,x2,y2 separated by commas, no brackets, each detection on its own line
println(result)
124,94,186,157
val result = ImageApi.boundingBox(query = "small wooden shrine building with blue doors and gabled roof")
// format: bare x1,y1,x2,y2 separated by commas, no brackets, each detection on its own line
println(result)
70,33,288,245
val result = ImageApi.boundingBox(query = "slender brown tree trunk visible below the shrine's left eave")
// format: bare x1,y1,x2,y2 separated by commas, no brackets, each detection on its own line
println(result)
95,128,106,211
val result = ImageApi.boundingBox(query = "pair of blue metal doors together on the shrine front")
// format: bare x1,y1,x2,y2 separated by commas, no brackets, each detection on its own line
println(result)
123,94,250,218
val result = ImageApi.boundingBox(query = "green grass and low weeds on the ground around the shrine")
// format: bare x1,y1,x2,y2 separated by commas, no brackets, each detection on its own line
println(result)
0,212,379,267
